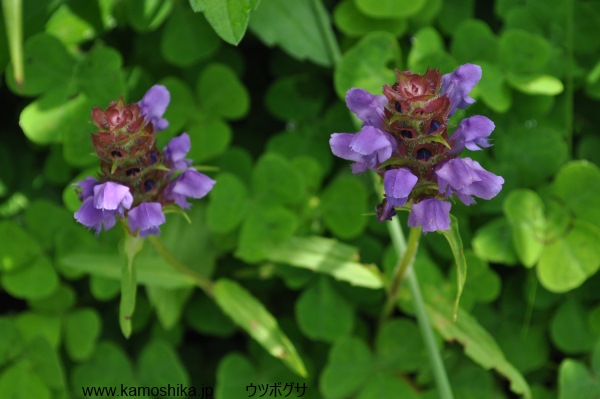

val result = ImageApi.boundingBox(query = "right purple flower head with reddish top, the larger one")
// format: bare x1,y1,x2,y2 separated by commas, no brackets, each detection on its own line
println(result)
329,64,504,232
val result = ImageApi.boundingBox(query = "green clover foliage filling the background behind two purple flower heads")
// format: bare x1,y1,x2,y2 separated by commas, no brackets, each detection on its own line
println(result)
0,0,600,399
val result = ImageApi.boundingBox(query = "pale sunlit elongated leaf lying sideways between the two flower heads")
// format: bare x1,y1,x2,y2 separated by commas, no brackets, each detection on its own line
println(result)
266,236,383,289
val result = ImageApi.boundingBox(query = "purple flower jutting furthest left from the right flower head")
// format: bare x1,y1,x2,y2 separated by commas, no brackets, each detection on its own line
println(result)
329,126,397,173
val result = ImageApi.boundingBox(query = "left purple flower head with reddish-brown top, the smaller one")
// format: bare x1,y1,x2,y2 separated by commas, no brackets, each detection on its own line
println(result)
75,85,215,237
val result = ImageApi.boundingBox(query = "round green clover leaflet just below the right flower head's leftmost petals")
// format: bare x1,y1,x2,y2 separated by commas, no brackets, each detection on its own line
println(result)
319,176,368,239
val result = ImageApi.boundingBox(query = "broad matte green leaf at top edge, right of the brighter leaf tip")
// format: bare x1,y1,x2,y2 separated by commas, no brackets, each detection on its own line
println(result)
250,0,333,66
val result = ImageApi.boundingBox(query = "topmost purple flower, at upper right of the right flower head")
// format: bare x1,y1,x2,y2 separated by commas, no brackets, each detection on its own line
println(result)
442,64,481,116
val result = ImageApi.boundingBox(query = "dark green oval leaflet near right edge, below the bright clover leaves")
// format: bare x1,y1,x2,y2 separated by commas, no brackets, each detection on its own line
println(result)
550,298,596,355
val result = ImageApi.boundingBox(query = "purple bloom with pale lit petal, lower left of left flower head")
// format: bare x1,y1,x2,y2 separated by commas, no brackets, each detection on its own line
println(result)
75,182,133,234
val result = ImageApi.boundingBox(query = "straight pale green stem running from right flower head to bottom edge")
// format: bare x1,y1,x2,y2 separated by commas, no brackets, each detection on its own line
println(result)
386,217,454,399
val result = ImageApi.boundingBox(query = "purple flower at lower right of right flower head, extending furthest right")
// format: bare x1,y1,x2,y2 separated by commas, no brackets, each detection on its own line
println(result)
435,158,504,205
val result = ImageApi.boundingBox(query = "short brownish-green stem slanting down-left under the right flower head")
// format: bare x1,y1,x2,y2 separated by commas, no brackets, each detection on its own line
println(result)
379,227,421,327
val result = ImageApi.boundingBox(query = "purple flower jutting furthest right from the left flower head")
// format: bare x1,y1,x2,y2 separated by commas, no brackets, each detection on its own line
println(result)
165,168,216,209
